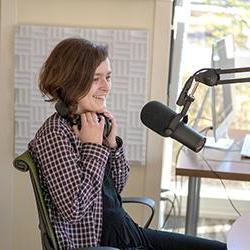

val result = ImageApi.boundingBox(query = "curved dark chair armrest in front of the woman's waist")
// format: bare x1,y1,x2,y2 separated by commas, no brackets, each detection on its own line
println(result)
122,197,155,228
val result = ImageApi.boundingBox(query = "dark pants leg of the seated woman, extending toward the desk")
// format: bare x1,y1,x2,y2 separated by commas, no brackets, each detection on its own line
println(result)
143,229,227,250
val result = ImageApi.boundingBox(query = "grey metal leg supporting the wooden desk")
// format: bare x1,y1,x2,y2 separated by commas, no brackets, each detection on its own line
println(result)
185,177,201,236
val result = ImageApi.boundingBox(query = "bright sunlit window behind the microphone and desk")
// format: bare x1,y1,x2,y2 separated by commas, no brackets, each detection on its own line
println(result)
160,0,250,241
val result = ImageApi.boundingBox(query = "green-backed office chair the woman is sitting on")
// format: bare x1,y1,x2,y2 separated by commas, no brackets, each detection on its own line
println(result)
13,150,155,250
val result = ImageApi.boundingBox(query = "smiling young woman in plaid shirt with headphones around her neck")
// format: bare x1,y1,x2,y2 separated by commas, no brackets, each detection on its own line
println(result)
29,38,226,250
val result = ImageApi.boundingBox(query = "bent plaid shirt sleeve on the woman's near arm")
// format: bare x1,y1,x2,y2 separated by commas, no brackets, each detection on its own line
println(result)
33,131,110,222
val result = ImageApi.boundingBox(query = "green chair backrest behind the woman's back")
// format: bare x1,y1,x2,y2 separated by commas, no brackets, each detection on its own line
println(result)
13,150,59,250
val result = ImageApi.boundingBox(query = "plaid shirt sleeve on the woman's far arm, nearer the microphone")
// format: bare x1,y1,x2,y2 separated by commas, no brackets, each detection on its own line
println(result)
110,137,129,193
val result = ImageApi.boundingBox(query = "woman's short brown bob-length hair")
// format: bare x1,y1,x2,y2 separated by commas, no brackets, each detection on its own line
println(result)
39,38,108,112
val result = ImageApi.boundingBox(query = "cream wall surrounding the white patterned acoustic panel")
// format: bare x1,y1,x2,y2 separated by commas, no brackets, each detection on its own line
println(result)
0,0,172,250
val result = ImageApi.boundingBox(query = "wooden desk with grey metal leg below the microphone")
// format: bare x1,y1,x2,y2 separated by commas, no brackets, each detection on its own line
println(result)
176,130,250,235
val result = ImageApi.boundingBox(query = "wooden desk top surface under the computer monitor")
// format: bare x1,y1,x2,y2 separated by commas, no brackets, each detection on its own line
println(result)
176,130,250,181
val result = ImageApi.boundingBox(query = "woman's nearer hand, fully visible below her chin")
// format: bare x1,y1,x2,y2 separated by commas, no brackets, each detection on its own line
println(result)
73,112,105,145
